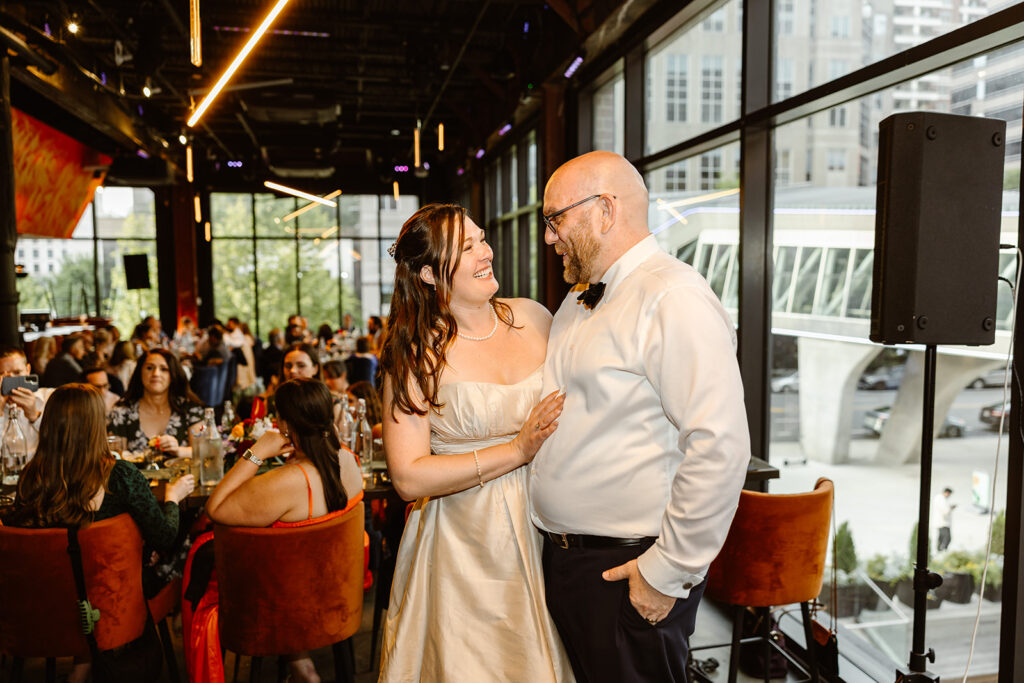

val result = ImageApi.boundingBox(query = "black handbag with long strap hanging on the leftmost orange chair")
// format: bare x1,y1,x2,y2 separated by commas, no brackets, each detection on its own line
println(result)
68,528,164,683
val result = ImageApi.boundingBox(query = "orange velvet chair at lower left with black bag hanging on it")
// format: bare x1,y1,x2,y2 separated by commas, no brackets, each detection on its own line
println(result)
0,514,147,681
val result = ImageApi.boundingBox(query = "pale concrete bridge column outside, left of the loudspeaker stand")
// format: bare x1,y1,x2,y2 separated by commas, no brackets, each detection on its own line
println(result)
797,337,881,465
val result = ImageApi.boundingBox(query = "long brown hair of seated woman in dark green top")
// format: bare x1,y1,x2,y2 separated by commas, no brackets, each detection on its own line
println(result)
11,384,114,528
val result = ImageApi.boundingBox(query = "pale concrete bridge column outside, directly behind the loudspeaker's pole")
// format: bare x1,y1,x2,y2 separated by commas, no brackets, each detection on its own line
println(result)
876,351,1001,466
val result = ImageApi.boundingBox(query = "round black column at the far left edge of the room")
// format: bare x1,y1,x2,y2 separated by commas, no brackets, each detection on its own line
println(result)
0,56,22,345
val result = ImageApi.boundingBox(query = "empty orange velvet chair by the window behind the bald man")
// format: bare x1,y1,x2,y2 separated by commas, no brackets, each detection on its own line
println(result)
693,478,834,683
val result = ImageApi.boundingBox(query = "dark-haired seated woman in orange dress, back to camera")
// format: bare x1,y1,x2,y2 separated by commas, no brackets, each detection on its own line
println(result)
200,379,362,681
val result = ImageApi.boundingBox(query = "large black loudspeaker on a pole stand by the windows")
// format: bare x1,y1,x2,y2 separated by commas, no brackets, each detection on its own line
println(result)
870,112,1007,346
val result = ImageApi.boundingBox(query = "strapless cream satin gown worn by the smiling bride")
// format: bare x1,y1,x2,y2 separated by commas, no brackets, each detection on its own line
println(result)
379,369,573,683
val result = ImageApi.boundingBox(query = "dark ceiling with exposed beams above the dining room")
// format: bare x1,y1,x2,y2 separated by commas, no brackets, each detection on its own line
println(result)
0,0,616,190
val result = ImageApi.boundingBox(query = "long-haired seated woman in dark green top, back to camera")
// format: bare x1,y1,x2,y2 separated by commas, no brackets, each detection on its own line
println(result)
5,384,196,683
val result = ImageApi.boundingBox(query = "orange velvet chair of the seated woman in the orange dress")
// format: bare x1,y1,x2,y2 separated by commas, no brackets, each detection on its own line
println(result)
214,502,364,682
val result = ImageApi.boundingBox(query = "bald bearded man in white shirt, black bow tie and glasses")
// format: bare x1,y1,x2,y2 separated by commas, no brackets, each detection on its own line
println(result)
530,152,751,683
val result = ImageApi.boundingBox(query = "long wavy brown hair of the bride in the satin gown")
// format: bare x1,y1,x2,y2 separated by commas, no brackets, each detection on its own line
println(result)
381,204,515,419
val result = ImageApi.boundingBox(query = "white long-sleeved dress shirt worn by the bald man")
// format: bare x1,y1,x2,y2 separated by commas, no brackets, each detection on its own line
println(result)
530,236,751,598
